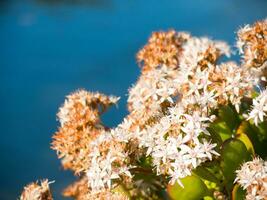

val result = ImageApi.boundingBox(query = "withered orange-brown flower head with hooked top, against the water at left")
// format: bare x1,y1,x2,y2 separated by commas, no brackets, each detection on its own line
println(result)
52,90,118,173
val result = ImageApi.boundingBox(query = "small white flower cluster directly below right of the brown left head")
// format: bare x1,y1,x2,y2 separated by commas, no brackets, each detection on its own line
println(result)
86,130,131,191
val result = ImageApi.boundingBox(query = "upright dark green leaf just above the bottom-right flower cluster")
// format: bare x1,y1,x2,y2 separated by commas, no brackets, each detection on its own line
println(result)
221,139,251,191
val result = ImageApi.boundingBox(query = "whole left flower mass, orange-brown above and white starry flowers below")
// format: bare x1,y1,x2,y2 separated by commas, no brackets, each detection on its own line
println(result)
52,90,134,199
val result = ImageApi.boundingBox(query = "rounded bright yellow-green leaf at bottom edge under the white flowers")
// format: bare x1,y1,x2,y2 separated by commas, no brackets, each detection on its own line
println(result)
167,175,209,200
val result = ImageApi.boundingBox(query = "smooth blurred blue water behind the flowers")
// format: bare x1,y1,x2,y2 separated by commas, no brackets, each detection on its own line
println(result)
0,0,267,200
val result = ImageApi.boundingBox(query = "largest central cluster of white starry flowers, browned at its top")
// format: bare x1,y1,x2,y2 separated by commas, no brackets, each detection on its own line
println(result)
127,32,255,186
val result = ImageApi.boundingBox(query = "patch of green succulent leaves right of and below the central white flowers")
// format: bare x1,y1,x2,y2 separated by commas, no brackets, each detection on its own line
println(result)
167,106,267,200
